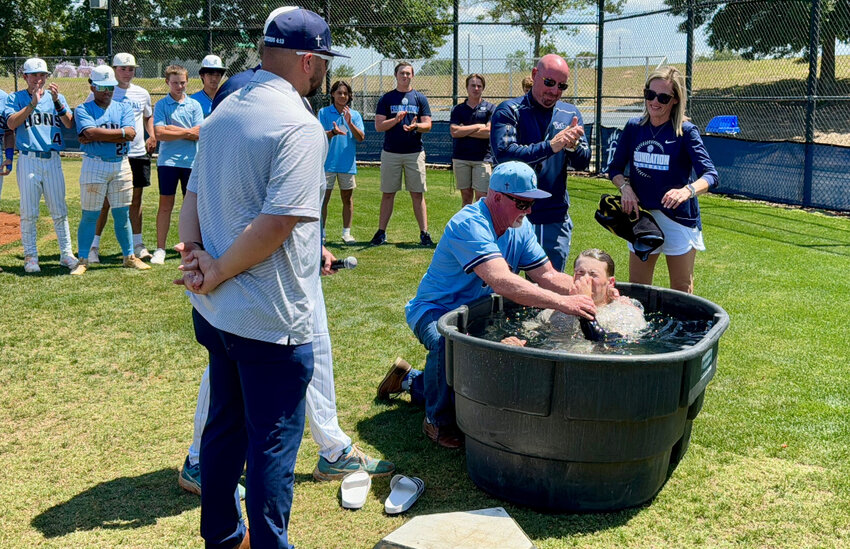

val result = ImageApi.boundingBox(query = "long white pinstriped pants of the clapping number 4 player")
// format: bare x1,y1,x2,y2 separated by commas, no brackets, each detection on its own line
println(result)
16,151,73,257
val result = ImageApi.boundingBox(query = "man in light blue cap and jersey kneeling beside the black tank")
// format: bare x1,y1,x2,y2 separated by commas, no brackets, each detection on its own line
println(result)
378,162,596,448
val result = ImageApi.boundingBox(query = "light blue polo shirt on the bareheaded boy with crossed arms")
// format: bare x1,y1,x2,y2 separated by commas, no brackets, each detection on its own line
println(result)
153,94,204,168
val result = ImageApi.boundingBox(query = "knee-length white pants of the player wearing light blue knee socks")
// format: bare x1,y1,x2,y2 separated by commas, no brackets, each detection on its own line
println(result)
80,156,133,211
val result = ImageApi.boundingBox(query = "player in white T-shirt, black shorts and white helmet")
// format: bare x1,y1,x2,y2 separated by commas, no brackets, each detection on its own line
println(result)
88,53,156,264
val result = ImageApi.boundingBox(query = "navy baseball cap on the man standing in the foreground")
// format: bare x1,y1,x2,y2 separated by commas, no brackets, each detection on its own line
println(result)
263,8,348,57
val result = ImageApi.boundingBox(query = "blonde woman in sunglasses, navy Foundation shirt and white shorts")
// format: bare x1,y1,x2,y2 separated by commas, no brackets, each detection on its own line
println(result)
609,67,718,293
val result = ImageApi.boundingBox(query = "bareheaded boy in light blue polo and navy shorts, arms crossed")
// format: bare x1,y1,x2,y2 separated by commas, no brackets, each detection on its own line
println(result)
151,65,204,265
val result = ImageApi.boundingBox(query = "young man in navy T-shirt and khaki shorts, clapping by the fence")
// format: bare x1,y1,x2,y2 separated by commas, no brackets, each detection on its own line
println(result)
370,63,434,246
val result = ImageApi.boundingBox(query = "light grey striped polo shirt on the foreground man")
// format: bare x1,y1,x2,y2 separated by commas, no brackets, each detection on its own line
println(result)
188,70,328,345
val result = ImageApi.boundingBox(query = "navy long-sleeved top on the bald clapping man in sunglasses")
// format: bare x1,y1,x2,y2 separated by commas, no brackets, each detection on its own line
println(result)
490,92,591,225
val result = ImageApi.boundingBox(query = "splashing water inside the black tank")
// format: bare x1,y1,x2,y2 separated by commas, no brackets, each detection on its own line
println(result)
469,301,714,355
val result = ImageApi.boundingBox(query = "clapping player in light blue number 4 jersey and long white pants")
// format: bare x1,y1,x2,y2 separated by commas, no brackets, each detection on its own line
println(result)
4,57,77,273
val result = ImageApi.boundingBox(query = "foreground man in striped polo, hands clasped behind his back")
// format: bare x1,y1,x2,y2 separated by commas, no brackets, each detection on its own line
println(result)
178,9,348,548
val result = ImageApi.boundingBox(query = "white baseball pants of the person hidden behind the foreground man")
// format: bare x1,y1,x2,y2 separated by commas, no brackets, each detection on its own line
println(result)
189,281,351,465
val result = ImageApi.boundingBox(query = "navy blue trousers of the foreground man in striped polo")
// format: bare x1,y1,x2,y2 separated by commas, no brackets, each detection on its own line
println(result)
192,310,313,549
